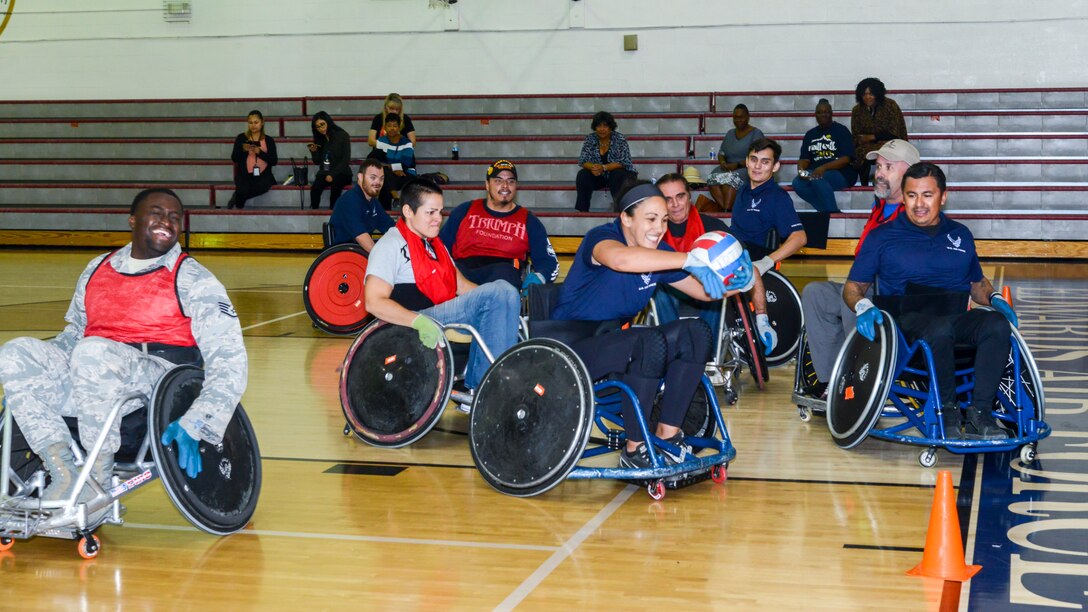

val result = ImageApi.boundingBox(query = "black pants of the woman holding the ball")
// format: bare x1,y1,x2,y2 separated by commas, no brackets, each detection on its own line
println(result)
571,319,710,442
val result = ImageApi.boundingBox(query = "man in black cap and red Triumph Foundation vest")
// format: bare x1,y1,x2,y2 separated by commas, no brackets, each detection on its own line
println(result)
438,159,559,287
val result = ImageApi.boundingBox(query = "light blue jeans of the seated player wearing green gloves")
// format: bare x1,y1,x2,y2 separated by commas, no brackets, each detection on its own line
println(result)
420,281,521,389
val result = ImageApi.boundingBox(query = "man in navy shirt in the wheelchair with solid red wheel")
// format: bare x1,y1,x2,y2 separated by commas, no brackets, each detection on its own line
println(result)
329,159,394,253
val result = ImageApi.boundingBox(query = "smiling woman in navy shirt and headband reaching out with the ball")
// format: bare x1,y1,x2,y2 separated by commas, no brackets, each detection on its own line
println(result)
551,181,752,468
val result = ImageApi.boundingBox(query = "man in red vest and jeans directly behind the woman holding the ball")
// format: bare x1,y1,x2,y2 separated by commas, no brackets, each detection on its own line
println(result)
654,174,778,353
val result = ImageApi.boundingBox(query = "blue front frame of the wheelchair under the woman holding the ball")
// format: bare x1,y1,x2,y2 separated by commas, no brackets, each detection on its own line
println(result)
567,376,737,499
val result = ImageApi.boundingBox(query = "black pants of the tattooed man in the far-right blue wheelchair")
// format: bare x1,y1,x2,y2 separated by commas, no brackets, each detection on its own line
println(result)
897,310,1012,411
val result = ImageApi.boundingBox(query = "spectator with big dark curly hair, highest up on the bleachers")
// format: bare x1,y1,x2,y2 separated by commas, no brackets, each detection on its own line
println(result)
850,76,910,186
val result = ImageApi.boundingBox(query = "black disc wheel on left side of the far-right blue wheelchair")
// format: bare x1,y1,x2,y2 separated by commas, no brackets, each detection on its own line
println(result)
827,313,899,449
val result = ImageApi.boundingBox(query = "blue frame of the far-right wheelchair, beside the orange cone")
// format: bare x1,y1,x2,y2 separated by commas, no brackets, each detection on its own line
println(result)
852,313,1051,467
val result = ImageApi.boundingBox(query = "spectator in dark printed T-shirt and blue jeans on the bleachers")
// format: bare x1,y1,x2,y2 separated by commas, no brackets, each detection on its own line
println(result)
793,98,857,212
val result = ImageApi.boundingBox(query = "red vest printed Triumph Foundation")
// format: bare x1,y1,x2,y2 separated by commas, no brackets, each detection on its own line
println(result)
454,199,529,260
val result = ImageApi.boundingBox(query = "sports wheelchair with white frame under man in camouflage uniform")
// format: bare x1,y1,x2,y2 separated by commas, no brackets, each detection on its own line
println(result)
0,365,261,559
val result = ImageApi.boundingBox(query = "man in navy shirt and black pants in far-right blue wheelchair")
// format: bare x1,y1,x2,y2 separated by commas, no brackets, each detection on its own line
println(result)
842,162,1017,440
